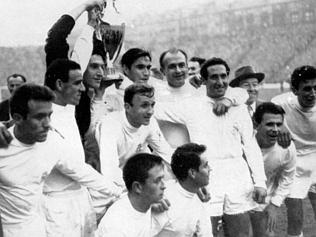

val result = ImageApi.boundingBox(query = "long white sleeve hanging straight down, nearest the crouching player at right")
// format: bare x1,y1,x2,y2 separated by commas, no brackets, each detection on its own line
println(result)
238,105,266,188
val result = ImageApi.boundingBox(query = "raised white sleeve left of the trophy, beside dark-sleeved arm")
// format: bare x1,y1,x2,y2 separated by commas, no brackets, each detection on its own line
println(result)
71,25,94,72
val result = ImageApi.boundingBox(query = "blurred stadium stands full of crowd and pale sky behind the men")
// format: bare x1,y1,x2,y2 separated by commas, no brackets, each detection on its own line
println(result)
0,0,316,99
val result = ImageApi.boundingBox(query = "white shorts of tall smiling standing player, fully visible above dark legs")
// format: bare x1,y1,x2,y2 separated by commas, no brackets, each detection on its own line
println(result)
208,158,258,216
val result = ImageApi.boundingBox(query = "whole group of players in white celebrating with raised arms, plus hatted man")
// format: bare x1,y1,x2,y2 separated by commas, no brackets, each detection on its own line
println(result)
0,0,316,237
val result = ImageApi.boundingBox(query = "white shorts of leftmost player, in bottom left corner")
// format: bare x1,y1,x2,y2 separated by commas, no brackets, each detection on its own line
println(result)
2,215,46,237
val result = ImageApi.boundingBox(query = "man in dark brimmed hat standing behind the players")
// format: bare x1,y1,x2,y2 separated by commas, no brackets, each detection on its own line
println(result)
229,66,264,117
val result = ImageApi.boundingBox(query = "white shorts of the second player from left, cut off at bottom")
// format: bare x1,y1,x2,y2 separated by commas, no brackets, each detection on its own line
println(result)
43,188,97,237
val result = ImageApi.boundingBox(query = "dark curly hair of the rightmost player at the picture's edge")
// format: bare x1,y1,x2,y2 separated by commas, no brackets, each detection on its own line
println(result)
291,65,316,90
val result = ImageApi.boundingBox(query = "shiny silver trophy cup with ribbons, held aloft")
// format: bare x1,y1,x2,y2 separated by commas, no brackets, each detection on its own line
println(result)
97,0,125,80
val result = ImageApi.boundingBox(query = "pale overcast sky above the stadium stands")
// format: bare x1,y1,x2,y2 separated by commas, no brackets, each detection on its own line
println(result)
0,0,214,46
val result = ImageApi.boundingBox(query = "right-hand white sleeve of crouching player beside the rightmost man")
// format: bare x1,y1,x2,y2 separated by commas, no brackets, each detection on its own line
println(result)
271,143,296,206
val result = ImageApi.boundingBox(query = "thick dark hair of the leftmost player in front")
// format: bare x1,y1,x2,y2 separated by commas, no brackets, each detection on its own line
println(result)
9,83,55,119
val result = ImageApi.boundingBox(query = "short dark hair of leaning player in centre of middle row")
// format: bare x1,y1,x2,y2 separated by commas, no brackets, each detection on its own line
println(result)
124,83,155,105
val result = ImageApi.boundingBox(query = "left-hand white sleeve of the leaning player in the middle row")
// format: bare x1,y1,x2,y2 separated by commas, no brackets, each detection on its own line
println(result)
95,116,124,186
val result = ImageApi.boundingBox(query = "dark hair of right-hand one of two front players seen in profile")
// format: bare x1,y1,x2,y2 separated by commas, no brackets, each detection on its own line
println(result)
171,143,206,181
